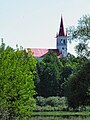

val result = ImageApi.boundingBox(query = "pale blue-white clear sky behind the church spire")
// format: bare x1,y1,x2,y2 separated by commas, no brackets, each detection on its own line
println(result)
0,0,90,54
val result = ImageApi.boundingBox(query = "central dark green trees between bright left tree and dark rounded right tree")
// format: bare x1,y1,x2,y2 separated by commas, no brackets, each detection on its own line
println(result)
36,51,78,97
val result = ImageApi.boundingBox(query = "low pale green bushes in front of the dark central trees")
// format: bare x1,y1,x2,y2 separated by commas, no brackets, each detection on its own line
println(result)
35,96,67,111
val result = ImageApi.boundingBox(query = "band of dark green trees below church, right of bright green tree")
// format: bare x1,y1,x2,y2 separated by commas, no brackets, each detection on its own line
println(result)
35,51,90,108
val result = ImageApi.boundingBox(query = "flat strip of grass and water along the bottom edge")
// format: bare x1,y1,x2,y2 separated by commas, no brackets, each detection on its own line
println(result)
30,111,90,120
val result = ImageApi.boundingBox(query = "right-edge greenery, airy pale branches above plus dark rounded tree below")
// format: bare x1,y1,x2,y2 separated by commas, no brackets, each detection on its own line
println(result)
65,15,90,108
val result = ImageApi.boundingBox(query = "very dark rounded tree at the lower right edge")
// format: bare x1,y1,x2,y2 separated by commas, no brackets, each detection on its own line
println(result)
65,60,90,109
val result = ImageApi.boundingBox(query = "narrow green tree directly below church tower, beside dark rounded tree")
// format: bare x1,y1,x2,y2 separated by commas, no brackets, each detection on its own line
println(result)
60,53,79,96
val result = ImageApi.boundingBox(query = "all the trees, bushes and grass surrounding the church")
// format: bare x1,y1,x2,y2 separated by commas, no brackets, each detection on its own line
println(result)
0,15,90,120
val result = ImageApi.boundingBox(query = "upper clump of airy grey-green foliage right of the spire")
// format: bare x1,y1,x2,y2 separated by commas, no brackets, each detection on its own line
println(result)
68,15,90,42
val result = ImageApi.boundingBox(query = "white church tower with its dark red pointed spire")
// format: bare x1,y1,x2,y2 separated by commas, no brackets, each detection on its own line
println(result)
56,16,67,57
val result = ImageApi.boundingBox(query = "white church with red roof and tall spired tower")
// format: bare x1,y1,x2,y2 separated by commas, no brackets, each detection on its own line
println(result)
28,16,67,60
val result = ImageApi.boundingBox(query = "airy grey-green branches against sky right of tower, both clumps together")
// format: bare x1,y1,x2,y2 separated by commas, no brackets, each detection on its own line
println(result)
68,15,90,56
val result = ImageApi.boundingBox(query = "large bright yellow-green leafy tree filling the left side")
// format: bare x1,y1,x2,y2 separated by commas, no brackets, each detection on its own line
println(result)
0,42,36,120
